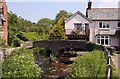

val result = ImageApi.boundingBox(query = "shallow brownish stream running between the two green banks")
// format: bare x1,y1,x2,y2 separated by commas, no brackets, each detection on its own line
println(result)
35,51,77,79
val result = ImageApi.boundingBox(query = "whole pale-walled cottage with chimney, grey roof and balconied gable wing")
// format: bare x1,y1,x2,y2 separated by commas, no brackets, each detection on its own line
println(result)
65,1,120,49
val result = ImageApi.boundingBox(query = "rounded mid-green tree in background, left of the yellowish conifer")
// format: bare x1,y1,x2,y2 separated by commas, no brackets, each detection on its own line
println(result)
37,18,53,34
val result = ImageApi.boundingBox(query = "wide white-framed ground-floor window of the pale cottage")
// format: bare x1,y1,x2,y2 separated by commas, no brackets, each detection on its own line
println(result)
97,36,110,45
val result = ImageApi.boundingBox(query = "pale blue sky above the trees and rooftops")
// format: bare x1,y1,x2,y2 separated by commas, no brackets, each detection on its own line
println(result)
7,0,119,23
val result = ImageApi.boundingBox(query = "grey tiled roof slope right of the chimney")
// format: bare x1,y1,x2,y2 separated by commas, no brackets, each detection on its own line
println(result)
88,8,120,20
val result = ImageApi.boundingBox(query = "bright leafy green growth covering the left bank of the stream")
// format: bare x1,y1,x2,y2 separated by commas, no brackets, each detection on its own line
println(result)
2,48,41,78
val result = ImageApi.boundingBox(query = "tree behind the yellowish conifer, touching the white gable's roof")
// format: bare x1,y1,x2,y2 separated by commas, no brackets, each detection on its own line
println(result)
55,10,72,23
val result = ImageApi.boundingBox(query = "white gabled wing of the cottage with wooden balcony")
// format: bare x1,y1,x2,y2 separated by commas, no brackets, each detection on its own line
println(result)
65,11,92,40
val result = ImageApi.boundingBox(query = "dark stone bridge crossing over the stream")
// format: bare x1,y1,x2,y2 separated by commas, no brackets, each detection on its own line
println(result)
33,40,86,56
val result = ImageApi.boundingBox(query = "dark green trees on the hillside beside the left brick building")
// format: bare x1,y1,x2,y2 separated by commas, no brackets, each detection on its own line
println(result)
8,12,40,46
